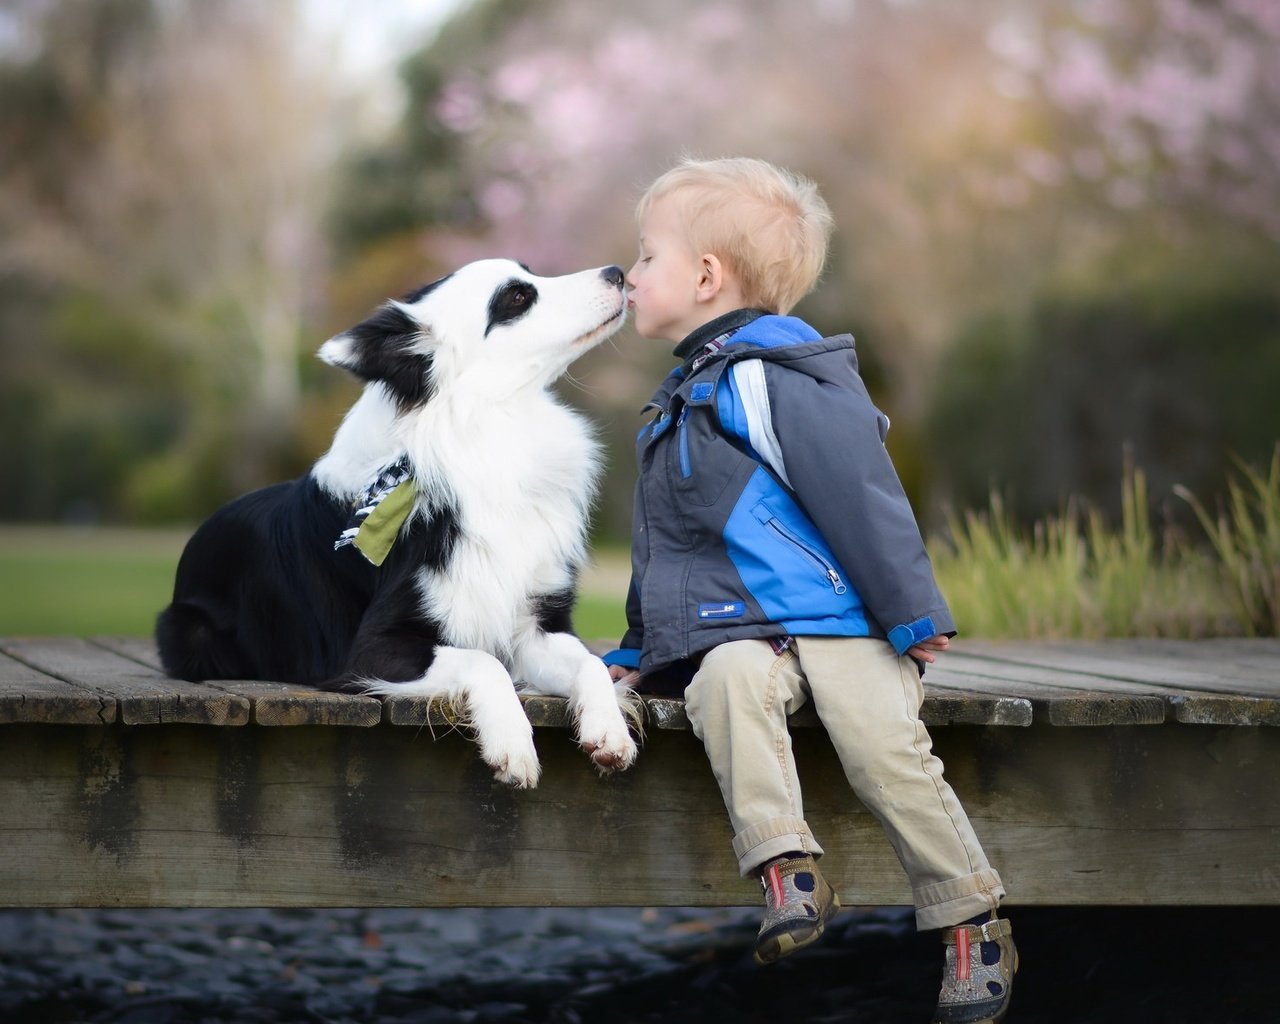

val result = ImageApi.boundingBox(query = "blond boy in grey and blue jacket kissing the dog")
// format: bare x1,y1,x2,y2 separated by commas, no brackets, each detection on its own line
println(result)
605,159,1016,1021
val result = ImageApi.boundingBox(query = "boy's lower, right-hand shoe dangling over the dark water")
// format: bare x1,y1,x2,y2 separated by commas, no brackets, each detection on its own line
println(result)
933,914,1018,1024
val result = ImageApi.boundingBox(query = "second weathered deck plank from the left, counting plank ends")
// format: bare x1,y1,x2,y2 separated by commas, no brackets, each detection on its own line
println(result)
0,637,248,726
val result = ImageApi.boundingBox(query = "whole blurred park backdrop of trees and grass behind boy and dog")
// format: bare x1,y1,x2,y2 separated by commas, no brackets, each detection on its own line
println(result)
0,0,1280,635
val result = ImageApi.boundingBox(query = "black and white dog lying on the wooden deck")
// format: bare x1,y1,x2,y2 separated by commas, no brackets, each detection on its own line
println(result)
156,260,636,787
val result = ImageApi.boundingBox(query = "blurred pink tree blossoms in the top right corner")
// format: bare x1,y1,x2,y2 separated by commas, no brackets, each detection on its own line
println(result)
1013,0,1280,242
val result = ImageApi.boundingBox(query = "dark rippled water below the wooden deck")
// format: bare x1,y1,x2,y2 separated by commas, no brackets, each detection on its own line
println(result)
0,908,1280,1024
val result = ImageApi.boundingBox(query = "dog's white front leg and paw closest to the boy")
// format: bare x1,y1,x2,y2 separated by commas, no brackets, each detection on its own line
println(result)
516,632,639,772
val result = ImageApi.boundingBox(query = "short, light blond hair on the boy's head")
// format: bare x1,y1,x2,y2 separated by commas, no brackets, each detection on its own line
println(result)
636,156,833,314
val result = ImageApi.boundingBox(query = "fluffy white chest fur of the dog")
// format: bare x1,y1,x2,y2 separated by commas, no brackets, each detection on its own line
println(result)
403,392,599,660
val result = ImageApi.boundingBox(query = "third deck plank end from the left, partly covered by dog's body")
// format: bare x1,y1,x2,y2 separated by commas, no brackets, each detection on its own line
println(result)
95,637,383,727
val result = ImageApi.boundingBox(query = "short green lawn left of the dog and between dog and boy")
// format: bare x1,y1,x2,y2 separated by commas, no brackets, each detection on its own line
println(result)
0,526,626,641
